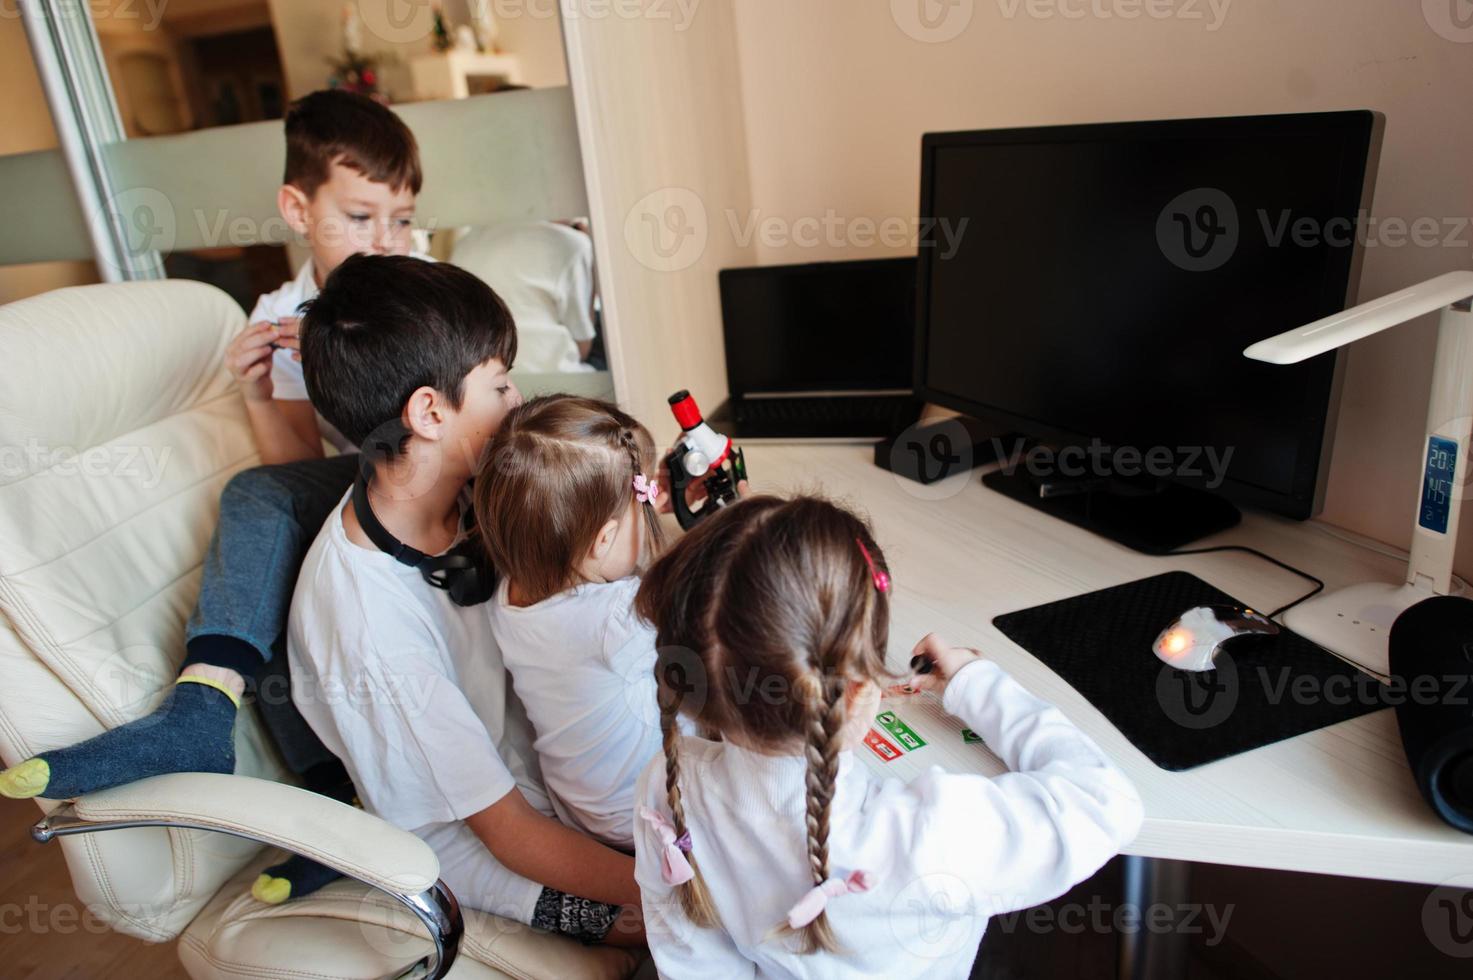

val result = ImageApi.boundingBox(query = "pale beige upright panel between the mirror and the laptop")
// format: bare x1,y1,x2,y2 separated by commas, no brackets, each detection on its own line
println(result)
563,0,756,427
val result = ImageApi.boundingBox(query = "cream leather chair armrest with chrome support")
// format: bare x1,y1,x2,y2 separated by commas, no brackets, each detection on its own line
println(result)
31,772,464,977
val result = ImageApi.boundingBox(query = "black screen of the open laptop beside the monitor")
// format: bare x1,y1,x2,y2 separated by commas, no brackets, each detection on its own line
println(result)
720,258,916,395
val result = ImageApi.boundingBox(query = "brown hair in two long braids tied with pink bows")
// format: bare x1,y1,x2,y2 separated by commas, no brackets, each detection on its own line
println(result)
635,497,891,953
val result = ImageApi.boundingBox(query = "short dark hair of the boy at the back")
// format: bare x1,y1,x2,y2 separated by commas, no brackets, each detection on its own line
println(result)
281,88,424,197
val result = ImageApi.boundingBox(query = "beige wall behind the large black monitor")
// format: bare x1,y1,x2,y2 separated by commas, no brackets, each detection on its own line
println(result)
730,0,1473,570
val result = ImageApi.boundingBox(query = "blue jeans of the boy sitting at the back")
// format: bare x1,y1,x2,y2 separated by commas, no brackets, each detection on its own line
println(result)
184,455,358,774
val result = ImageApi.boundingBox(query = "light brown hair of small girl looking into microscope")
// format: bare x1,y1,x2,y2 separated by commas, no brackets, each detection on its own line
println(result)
473,395,661,603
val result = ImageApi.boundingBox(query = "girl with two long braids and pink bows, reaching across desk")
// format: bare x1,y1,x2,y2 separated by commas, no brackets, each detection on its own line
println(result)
635,497,1142,979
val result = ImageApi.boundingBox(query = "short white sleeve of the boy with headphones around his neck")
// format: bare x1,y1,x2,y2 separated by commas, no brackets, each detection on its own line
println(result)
293,630,516,830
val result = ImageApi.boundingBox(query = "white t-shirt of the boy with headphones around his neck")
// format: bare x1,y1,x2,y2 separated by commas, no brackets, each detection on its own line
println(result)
287,491,552,923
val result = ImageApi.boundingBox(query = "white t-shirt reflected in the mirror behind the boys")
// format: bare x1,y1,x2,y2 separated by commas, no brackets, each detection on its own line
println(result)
451,221,594,371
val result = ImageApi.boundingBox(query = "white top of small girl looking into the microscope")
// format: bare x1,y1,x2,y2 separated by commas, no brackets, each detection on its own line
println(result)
488,576,660,850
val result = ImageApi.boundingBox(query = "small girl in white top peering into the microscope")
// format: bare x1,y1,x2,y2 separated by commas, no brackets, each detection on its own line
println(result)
473,395,671,850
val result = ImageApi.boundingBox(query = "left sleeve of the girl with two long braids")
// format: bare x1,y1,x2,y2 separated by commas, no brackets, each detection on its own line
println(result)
635,755,757,980
